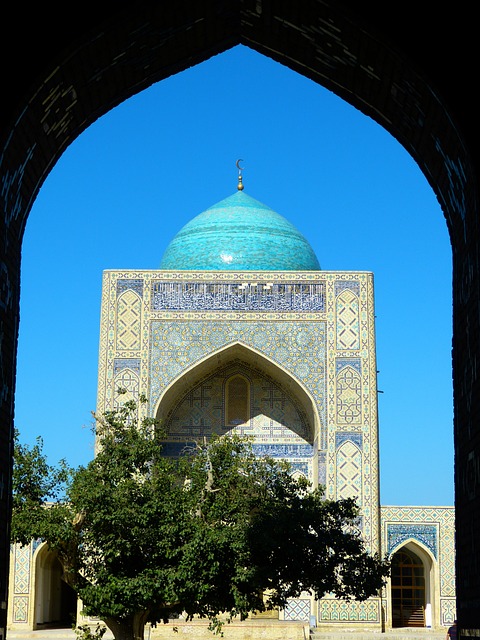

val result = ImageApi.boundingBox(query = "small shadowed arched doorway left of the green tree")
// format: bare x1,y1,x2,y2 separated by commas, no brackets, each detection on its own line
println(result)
33,544,77,629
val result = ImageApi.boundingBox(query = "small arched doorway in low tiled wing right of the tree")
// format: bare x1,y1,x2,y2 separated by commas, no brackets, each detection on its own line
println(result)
391,544,433,628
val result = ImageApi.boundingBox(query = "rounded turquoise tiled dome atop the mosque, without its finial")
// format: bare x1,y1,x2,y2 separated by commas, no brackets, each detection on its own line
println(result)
160,191,320,271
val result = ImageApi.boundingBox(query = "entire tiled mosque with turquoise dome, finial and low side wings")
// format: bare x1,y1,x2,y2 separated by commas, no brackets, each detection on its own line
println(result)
8,171,456,631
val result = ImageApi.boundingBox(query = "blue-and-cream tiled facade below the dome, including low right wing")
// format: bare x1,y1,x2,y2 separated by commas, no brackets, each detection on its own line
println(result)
94,270,455,629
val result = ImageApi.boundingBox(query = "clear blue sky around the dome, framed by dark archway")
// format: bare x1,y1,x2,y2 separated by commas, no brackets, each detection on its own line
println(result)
15,47,453,505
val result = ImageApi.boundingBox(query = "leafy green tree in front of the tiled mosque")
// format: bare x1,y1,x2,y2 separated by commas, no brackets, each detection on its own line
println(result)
12,399,389,640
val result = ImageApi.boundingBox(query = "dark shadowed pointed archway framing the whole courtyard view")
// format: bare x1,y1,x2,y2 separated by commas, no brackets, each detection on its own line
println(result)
0,0,480,637
